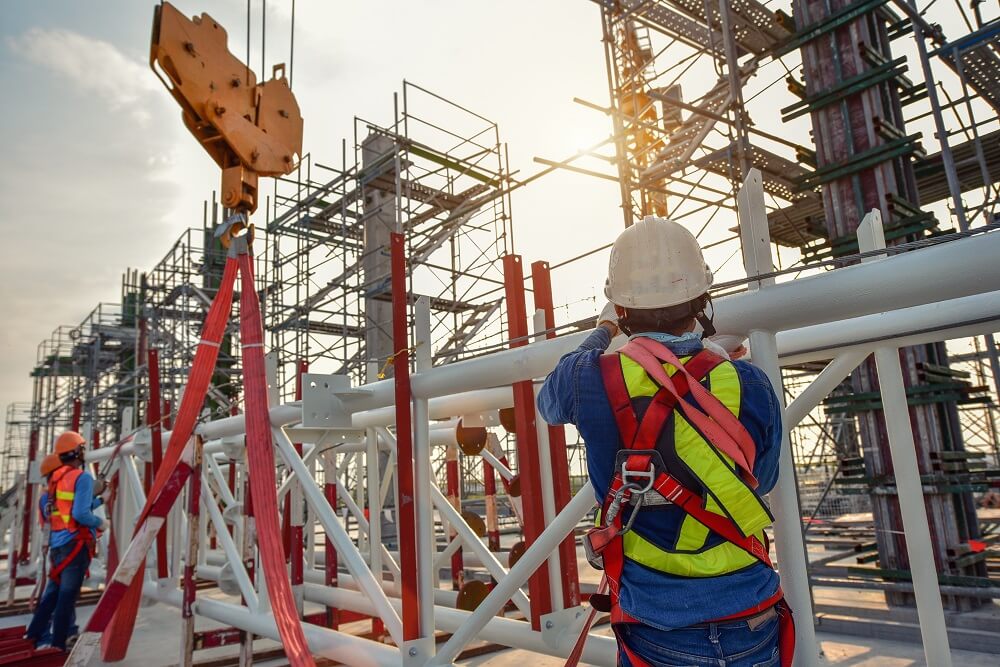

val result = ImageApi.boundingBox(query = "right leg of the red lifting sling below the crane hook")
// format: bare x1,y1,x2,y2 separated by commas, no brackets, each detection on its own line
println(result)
239,253,315,667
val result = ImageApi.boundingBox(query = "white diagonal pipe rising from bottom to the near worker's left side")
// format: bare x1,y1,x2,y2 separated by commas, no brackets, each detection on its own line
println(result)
430,481,597,665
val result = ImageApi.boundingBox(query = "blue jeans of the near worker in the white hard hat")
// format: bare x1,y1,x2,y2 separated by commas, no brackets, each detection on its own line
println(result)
620,616,780,667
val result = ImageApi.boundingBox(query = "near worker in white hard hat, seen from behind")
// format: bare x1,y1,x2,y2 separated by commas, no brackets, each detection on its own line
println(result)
538,217,794,667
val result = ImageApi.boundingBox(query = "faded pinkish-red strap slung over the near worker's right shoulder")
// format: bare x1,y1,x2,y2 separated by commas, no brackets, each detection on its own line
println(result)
619,336,757,488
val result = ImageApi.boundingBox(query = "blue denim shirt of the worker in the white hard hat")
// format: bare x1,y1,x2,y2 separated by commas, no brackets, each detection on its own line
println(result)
538,327,781,630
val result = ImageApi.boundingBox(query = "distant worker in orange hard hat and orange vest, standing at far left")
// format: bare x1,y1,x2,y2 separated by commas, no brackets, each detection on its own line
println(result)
26,431,108,651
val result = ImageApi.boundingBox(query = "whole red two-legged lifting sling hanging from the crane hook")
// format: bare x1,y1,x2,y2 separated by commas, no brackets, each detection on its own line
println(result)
66,222,314,667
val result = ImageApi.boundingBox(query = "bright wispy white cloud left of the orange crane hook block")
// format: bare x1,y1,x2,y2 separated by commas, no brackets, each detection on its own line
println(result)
7,28,157,125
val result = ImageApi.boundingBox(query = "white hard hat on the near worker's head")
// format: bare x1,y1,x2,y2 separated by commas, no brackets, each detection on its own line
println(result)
604,215,712,308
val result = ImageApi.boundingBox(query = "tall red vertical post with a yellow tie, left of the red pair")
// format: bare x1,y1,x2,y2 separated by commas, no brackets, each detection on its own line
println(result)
389,233,420,641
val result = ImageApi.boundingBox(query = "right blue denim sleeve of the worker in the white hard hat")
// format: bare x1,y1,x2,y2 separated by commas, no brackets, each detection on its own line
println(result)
733,361,782,494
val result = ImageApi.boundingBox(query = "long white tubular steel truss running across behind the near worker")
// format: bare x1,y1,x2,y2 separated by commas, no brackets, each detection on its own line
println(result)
5,170,1000,665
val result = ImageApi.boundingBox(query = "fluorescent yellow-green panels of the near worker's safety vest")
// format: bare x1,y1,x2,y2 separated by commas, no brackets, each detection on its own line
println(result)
618,355,773,577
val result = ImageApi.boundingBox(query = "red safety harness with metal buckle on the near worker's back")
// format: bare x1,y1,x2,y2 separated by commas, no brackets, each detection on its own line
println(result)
580,338,795,667
